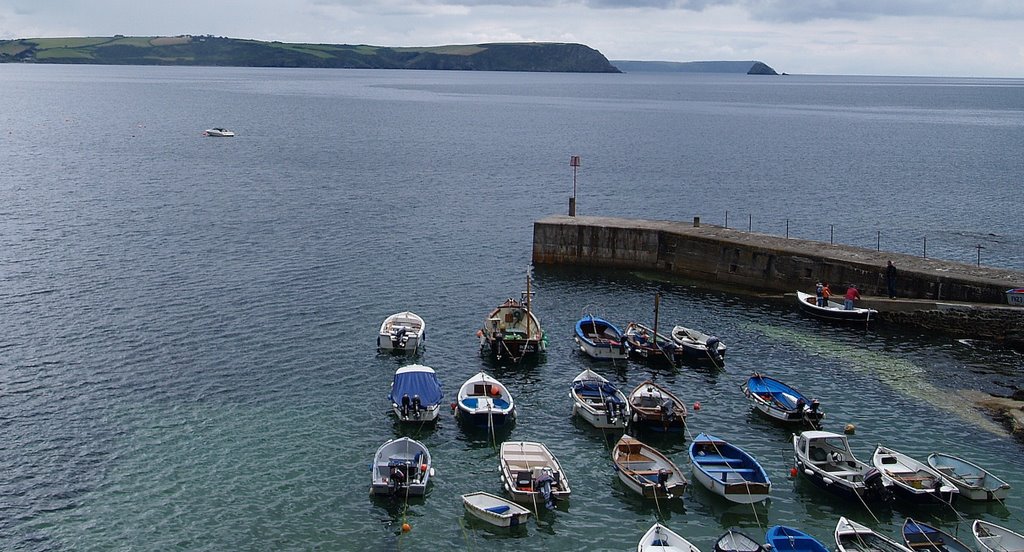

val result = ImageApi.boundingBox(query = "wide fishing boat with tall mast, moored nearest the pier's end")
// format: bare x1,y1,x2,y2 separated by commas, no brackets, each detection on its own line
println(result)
476,275,548,363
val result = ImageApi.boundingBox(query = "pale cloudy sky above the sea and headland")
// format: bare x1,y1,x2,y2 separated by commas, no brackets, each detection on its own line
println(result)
0,0,1024,78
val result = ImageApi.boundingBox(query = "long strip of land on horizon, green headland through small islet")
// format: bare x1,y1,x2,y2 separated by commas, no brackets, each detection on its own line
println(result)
0,35,775,75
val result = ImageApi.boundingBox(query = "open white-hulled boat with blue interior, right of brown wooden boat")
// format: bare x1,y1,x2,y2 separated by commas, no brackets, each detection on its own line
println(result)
690,433,771,504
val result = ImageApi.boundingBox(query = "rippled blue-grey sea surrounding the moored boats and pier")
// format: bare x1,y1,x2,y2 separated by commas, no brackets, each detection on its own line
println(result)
0,65,1024,551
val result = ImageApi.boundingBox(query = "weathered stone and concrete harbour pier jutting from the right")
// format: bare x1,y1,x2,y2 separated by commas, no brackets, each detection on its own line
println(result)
532,215,1024,348
